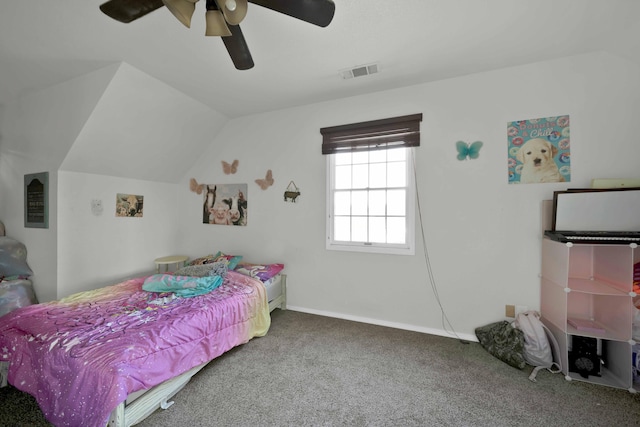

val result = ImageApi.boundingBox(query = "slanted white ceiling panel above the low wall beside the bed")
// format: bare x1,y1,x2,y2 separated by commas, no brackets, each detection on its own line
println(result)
60,63,228,183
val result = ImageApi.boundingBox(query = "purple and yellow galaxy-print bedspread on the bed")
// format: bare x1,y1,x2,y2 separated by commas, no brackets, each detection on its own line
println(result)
0,271,271,427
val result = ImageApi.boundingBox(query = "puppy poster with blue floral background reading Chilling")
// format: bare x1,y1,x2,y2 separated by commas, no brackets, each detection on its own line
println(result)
507,115,571,184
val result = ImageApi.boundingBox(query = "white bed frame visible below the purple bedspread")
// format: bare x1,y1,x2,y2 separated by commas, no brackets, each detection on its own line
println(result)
107,274,287,427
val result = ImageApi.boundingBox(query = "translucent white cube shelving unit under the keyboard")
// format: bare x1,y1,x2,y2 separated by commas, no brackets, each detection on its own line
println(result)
540,237,640,393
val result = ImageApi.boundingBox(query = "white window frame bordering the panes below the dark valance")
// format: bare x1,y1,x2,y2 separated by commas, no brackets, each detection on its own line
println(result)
326,147,416,255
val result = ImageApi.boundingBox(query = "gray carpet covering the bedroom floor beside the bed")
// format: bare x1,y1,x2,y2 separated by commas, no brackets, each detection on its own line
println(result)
0,310,640,427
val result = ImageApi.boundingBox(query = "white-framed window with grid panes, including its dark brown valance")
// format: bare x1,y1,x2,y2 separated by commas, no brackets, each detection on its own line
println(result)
320,114,422,255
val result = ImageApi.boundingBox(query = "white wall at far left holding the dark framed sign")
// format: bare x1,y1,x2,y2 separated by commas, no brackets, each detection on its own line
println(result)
0,67,116,301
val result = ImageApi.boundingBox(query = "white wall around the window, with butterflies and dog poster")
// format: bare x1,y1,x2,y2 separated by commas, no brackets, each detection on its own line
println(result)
177,53,640,338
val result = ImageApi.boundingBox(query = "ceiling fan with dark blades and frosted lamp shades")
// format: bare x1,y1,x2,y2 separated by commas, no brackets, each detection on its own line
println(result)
100,0,336,70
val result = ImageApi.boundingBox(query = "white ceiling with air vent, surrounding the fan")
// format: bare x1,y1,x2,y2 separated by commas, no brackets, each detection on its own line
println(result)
0,0,640,118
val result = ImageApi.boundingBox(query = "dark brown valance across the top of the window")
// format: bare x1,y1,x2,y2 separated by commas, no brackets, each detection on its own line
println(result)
320,114,422,154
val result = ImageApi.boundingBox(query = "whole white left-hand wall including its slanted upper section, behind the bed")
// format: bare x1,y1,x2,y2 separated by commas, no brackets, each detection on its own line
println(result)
0,63,227,301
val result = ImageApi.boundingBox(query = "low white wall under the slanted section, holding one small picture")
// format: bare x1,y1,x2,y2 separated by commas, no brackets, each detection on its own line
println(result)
57,172,180,297
